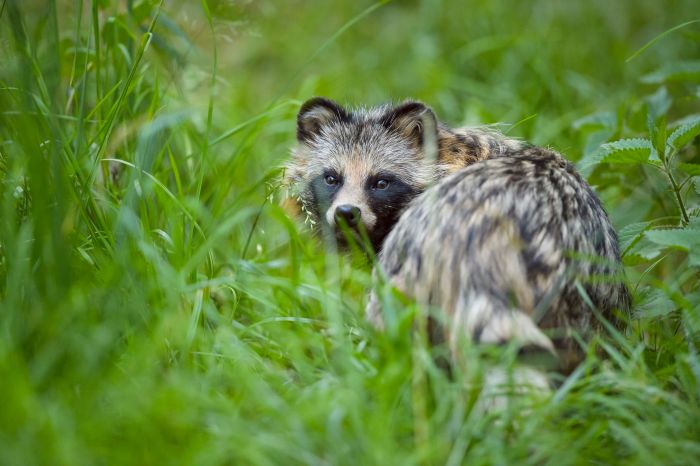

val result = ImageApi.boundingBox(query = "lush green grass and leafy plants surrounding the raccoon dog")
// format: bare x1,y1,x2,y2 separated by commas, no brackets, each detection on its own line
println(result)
0,0,700,465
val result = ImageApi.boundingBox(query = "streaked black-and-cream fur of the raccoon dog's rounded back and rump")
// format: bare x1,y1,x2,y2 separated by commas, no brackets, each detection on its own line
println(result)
368,147,629,370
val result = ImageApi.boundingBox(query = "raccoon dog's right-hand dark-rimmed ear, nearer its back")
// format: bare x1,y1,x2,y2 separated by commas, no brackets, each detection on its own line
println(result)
381,100,437,146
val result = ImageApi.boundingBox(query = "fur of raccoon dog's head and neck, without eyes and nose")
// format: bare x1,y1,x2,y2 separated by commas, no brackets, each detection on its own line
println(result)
285,98,525,251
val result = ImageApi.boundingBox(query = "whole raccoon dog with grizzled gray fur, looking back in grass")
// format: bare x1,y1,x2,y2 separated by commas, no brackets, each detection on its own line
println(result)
286,98,629,370
